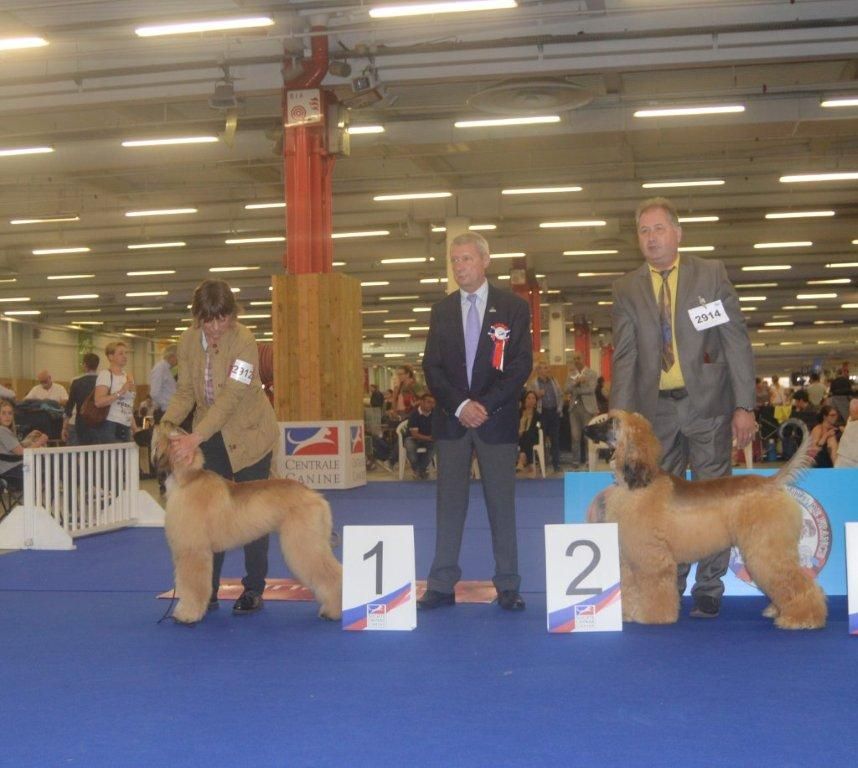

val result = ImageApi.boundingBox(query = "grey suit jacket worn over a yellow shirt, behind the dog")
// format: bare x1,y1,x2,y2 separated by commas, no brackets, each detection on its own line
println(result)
611,255,755,421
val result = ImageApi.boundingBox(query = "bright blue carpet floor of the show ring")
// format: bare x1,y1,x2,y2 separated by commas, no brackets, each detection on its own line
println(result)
0,481,858,768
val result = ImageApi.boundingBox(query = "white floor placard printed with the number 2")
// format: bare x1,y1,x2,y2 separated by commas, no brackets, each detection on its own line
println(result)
545,523,623,633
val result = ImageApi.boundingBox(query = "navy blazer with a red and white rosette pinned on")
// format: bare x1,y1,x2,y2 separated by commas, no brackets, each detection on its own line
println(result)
423,284,533,443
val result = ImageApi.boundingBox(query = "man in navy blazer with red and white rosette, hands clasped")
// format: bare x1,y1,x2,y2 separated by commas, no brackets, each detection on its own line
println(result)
417,232,533,610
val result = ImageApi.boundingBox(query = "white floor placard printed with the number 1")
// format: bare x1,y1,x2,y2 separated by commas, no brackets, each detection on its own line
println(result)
343,525,417,631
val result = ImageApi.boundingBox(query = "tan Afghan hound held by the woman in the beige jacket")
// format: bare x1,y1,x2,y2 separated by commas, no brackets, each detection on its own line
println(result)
152,423,343,624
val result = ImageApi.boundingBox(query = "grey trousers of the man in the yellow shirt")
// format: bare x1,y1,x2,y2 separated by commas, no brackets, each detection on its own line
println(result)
653,397,733,600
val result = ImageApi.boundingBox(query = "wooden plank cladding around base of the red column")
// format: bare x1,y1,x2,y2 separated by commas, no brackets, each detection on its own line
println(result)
271,272,364,421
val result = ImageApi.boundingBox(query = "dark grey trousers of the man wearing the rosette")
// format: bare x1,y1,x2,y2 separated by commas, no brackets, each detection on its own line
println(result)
427,429,521,593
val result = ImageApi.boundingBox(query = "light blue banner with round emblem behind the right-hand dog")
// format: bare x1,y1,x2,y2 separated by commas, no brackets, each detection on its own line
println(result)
564,469,858,595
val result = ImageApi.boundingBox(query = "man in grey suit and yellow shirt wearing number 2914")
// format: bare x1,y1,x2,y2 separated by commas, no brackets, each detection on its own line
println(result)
611,197,756,618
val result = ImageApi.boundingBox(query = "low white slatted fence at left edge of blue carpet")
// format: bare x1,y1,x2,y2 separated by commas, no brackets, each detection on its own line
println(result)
0,443,163,549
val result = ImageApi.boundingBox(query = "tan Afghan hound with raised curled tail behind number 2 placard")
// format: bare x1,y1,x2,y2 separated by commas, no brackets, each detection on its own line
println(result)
585,411,827,629
